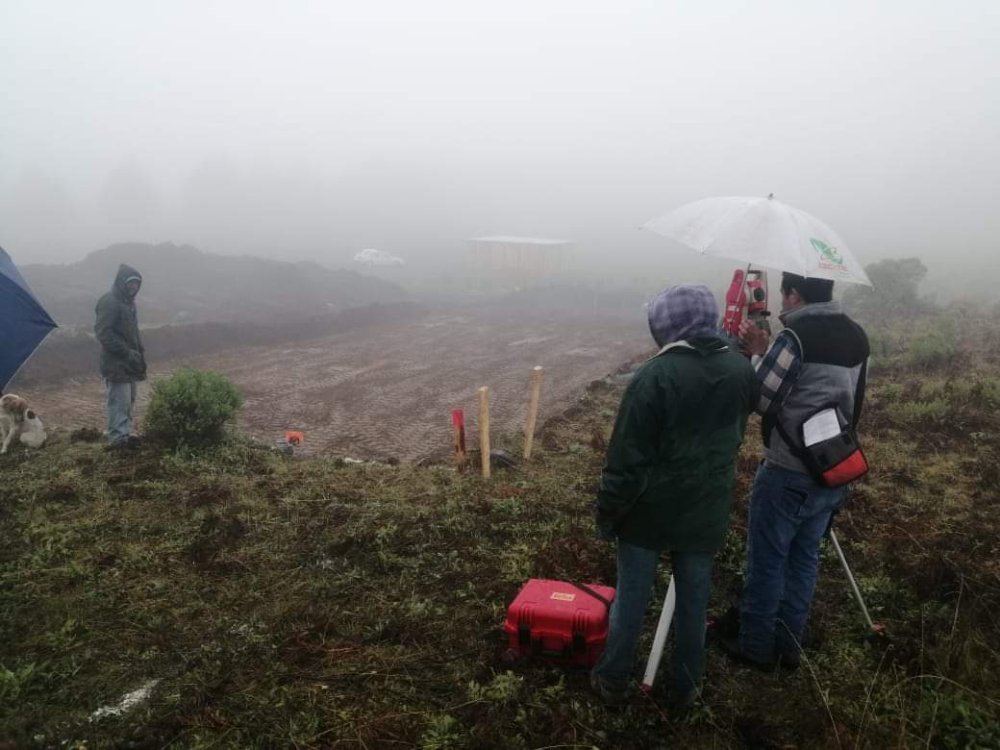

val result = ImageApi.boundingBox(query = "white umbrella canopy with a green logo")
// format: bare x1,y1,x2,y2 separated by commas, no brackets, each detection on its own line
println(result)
642,196,872,286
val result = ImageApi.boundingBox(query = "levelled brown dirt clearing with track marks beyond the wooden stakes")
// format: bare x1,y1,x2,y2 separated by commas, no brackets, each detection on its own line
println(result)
23,311,652,461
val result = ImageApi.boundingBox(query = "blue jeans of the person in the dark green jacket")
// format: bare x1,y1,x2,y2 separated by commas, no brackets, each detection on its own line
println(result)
594,542,715,696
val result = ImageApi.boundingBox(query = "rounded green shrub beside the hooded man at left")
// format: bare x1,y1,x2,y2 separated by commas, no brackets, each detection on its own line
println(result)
145,368,243,447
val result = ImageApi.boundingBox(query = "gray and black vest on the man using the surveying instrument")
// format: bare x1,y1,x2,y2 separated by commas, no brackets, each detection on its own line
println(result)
761,302,869,474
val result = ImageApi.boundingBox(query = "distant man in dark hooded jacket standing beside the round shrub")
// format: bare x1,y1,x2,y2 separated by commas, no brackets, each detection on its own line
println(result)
94,263,146,446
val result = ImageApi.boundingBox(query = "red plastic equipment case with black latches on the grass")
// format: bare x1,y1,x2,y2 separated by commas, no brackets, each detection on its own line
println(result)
504,578,615,667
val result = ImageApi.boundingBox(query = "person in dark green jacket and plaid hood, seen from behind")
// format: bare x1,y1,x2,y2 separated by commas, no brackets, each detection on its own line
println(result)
591,285,757,706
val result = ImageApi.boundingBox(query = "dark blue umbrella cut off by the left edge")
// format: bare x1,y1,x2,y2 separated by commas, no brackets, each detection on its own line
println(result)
0,247,56,391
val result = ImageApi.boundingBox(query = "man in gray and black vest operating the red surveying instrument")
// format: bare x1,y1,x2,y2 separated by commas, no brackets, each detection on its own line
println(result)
719,273,869,670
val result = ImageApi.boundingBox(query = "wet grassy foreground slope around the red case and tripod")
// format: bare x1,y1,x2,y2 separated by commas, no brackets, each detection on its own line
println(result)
0,314,1000,748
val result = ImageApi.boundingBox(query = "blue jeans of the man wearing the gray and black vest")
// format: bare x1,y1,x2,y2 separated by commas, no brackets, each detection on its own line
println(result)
740,464,847,663
